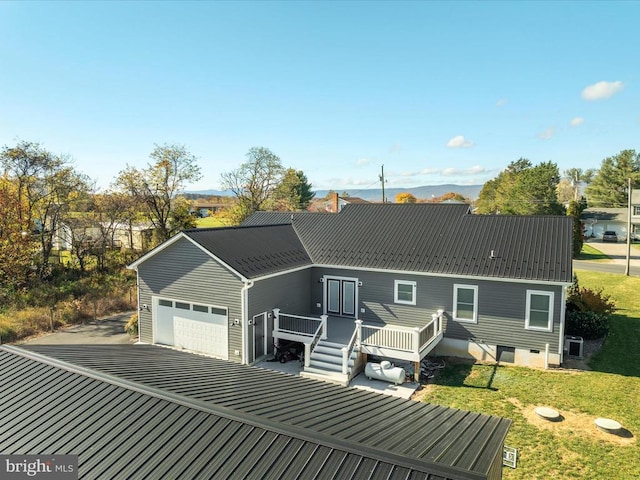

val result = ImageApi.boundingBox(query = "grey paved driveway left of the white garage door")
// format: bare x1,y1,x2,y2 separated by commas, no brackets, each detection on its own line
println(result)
20,312,136,345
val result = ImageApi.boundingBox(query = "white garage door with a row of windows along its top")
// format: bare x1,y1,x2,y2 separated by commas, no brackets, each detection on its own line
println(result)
153,298,229,360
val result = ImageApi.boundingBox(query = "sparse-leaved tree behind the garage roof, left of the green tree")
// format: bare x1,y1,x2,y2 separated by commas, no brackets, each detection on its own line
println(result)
220,147,284,223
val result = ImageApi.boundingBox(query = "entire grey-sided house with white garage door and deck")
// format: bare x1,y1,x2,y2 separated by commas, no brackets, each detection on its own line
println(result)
131,204,572,384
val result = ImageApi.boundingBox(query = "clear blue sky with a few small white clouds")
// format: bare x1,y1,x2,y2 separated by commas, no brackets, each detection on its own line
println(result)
0,1,640,191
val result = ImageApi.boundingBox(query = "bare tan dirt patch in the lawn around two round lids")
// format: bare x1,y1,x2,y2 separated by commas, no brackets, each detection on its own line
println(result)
520,399,636,446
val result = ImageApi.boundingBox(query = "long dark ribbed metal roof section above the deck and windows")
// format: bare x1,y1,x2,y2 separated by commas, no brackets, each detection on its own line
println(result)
294,204,573,282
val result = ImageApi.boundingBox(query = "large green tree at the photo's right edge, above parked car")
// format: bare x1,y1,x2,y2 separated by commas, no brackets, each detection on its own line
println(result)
586,150,640,207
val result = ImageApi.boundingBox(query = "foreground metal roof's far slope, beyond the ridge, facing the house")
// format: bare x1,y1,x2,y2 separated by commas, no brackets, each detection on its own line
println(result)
16,345,510,478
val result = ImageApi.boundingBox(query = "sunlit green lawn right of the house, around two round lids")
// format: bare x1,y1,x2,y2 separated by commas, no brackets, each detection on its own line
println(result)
423,270,640,480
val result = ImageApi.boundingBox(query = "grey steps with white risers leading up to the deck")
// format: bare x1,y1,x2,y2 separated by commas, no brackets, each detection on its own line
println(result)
300,340,357,386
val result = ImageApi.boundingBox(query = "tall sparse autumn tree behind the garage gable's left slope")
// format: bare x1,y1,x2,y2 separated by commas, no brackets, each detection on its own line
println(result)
116,144,202,243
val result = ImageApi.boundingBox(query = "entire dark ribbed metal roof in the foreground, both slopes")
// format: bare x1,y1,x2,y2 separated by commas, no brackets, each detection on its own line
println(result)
10,345,510,479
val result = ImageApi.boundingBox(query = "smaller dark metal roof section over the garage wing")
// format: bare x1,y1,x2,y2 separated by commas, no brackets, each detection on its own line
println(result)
183,225,311,278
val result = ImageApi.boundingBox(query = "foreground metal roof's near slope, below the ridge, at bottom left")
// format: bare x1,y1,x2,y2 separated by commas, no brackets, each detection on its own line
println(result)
0,346,472,480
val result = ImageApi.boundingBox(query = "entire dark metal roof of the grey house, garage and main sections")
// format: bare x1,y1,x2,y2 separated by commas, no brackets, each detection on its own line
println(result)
179,204,573,283
